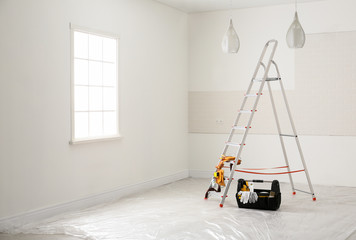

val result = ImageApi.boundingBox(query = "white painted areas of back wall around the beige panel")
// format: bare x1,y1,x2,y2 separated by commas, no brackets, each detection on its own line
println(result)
189,0,356,186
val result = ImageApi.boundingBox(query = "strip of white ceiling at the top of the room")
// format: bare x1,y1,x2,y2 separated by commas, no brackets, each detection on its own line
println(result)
156,0,323,13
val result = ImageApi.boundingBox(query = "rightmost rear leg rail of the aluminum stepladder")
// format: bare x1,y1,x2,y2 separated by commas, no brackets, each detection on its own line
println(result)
274,63,315,200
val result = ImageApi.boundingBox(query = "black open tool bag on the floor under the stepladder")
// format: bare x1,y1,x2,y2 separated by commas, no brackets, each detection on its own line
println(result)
236,179,281,210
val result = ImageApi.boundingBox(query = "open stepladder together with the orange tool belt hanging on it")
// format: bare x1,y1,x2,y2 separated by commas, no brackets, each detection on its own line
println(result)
205,39,316,207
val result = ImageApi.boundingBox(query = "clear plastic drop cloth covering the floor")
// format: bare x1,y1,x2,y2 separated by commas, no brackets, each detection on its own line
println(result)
4,178,356,240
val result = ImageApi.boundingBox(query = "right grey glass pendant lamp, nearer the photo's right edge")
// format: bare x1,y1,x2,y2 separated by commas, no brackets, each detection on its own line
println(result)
286,0,305,48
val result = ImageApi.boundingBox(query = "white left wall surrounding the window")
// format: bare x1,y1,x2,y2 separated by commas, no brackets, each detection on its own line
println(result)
0,0,188,218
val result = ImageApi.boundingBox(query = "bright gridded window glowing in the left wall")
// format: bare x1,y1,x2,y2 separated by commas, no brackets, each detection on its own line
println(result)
71,27,119,143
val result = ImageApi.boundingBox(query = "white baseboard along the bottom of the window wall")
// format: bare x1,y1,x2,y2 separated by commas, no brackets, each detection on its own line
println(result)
0,170,189,232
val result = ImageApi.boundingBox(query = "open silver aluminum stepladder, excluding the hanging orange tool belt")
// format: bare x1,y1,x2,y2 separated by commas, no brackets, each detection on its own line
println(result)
205,40,316,207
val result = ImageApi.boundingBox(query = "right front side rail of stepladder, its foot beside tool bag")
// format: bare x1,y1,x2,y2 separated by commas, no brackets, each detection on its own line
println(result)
220,40,278,207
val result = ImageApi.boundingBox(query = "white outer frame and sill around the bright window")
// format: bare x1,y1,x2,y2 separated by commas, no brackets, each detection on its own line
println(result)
69,24,121,144
